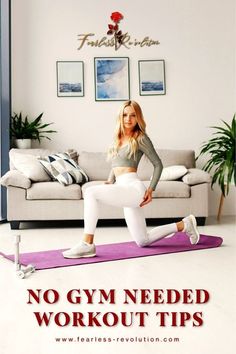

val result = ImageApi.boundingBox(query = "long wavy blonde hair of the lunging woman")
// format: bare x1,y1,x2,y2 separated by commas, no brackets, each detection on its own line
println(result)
108,101,146,159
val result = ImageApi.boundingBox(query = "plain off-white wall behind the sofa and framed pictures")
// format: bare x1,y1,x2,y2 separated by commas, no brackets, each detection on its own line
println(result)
12,0,236,214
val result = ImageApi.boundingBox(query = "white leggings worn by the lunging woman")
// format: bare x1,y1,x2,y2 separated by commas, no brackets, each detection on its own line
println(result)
84,172,178,247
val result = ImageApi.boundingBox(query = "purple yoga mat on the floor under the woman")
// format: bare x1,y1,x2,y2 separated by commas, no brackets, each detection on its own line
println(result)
0,232,223,270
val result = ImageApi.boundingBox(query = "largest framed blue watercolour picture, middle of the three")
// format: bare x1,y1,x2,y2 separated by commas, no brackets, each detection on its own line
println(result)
94,57,130,101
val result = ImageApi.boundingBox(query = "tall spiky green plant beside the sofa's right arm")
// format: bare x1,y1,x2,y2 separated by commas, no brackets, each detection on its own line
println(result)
197,114,236,220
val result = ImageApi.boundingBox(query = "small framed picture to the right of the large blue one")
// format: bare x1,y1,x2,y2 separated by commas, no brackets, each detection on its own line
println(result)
138,60,166,96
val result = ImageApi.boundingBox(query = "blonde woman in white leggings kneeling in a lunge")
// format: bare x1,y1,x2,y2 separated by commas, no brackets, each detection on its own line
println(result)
63,101,199,258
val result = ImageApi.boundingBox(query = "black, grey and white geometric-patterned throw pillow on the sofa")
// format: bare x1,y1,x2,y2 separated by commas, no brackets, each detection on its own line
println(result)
39,153,89,186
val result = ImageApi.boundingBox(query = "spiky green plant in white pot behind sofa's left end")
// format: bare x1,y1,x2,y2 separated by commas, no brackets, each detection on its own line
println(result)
10,112,56,149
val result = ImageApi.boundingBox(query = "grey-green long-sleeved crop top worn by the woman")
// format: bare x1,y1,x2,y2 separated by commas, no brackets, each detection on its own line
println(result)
108,135,163,190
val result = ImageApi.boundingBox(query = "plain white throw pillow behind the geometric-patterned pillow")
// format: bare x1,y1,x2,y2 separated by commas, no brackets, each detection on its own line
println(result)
11,152,51,182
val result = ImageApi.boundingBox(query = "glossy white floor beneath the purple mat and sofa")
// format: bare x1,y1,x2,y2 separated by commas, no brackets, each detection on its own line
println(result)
0,217,236,354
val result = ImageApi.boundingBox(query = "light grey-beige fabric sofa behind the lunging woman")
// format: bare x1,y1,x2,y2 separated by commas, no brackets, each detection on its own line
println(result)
0,149,210,229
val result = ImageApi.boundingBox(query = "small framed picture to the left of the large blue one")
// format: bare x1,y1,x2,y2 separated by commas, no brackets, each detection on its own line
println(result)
57,61,84,97
